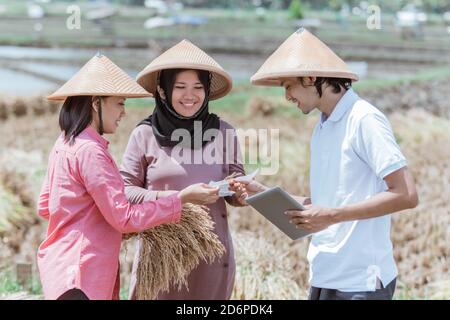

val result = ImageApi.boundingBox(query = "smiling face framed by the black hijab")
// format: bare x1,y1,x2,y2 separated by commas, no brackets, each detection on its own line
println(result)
172,70,206,117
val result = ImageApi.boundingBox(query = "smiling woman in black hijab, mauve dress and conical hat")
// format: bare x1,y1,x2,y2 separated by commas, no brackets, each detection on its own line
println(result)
121,40,245,300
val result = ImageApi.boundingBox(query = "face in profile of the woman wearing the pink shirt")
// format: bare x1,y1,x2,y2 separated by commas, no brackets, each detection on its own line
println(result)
93,97,126,134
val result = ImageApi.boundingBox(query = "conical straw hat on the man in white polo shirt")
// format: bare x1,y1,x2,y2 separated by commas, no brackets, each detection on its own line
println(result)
250,28,358,86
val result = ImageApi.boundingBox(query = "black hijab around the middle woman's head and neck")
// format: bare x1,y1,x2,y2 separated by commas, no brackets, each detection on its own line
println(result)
138,69,220,149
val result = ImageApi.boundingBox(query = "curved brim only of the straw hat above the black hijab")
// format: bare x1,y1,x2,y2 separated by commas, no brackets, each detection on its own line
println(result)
136,63,232,100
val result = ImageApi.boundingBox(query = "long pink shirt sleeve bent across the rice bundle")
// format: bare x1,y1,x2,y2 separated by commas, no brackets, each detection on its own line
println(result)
77,144,181,233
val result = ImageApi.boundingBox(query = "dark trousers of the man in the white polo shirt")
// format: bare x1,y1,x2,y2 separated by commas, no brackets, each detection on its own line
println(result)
308,279,397,300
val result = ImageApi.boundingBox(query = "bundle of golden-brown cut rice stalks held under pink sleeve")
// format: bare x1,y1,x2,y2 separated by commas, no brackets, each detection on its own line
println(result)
125,204,225,300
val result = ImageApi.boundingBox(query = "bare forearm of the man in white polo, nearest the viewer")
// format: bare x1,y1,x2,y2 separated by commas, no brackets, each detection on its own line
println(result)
333,190,415,223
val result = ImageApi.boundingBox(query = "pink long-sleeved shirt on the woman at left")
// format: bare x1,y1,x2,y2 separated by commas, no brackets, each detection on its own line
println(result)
37,127,181,299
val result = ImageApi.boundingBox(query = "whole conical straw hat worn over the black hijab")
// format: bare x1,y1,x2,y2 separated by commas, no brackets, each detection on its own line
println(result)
137,40,232,100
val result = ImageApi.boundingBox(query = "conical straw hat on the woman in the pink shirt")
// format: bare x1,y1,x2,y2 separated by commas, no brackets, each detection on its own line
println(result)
47,54,152,100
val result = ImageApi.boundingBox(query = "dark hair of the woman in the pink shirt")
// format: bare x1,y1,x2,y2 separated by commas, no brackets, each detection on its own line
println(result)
59,96,98,145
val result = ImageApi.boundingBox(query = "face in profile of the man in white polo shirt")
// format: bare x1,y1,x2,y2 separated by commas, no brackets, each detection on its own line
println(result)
282,77,320,114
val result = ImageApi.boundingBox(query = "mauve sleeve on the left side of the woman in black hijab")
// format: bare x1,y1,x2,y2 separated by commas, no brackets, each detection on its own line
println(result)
120,131,157,203
